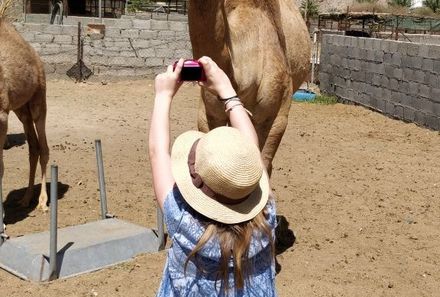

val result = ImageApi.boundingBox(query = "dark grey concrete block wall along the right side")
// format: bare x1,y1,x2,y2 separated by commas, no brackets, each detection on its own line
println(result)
319,35,440,130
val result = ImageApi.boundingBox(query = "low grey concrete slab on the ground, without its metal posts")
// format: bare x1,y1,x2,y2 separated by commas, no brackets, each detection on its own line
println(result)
0,219,159,282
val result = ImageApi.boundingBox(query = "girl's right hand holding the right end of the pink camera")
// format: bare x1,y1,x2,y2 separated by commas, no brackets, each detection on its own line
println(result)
199,56,237,98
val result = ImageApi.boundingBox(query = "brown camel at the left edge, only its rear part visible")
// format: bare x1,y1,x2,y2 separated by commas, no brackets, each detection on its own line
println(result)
0,18,49,211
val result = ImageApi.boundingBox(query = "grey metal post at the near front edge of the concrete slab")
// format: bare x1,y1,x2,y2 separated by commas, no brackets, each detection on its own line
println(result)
48,165,58,280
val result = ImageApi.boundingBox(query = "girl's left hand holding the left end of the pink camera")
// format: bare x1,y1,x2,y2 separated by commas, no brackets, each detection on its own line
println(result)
154,59,183,100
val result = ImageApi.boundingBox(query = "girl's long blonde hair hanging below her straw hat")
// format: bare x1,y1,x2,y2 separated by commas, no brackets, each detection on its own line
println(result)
184,208,275,292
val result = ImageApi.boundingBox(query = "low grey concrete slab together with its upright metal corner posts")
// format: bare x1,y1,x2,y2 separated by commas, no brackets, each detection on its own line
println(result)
0,140,164,282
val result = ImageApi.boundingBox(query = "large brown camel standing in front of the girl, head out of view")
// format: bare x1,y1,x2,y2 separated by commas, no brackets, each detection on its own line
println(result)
188,0,310,173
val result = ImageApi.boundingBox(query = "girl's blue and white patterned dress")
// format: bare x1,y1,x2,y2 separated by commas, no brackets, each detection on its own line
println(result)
157,187,276,297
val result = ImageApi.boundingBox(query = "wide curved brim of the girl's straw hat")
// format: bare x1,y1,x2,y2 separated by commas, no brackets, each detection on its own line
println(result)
171,131,269,224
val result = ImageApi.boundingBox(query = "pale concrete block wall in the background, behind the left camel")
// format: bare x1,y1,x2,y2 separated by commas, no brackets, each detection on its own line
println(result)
15,18,192,77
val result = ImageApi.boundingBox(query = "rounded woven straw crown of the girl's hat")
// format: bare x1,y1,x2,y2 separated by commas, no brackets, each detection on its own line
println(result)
194,127,264,199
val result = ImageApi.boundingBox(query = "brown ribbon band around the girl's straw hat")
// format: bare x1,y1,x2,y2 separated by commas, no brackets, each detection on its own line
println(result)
188,139,249,205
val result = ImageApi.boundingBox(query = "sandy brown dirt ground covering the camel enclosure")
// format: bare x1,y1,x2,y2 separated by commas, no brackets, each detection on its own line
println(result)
0,80,440,297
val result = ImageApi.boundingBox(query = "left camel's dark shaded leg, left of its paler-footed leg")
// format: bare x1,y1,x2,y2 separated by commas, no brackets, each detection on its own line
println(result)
14,103,39,207
